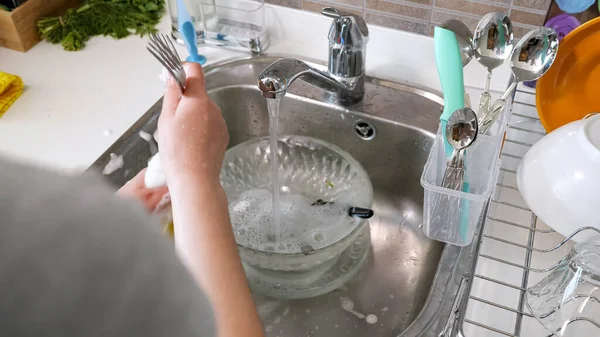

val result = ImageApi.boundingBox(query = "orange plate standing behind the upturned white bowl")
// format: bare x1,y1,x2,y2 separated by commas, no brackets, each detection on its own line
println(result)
536,17,600,132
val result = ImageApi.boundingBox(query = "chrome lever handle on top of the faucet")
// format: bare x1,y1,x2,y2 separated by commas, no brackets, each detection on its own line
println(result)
321,7,369,46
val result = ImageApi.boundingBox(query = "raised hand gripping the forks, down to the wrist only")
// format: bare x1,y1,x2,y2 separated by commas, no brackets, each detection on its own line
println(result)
158,63,229,186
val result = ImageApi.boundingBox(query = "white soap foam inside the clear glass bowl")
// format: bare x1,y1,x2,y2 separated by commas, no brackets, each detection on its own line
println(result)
229,189,360,254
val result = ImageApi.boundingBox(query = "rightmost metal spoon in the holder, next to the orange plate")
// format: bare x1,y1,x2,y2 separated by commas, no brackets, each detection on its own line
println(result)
479,27,558,133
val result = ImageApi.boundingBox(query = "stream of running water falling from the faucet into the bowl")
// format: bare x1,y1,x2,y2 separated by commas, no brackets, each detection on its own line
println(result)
267,98,281,241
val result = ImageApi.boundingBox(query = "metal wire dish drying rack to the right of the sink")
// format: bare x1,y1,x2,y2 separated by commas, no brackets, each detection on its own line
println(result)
439,84,600,337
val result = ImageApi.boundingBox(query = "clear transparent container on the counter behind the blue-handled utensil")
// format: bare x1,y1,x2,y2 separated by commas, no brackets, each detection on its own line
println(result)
168,0,269,53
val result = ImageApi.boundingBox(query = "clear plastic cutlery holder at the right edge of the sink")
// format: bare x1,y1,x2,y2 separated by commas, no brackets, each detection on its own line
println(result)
421,130,502,246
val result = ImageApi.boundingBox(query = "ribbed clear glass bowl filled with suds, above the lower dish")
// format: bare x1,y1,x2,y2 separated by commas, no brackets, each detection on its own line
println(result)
221,136,373,270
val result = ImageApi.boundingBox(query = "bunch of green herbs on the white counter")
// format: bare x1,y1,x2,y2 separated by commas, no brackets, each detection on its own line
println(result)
37,0,165,51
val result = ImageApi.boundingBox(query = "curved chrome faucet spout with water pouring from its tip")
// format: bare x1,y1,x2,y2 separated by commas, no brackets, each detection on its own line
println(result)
258,58,365,104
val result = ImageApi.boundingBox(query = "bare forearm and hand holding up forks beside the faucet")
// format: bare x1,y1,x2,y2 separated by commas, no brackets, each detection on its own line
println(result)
158,63,264,337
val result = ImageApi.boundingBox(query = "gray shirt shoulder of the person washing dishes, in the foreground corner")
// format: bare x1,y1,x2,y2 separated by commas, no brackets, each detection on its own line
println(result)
0,160,215,337
